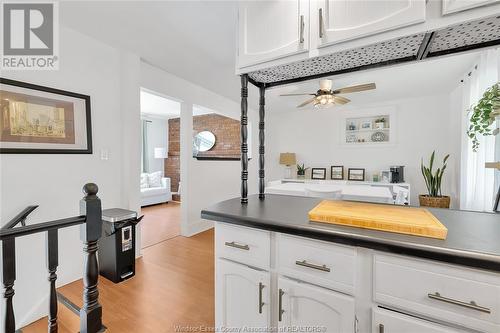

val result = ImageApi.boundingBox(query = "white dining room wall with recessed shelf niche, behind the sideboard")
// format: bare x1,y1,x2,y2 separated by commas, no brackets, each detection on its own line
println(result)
266,94,460,204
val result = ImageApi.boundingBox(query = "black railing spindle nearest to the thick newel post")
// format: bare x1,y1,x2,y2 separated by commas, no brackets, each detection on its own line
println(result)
46,229,59,333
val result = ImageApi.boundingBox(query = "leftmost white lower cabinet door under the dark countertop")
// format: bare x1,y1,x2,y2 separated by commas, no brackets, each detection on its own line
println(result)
215,259,271,332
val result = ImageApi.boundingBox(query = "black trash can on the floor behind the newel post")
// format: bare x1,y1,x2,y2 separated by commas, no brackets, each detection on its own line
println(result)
98,208,142,283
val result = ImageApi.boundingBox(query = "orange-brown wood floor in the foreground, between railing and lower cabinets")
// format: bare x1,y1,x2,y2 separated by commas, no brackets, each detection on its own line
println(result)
23,229,214,333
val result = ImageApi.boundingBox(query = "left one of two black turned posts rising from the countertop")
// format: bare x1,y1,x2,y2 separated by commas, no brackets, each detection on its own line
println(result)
241,74,248,204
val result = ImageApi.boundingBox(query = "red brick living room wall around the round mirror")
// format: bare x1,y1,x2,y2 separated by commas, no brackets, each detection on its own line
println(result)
165,113,241,199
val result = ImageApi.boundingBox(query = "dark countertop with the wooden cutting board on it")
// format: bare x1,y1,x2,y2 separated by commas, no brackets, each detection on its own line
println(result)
201,194,500,272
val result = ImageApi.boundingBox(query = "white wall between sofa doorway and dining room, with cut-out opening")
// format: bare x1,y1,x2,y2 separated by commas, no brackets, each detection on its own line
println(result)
141,63,258,235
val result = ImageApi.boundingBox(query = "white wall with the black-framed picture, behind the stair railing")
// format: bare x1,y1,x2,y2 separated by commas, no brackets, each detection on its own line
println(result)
0,26,140,327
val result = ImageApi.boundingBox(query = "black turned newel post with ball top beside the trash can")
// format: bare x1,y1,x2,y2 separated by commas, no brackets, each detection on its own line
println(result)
80,183,102,333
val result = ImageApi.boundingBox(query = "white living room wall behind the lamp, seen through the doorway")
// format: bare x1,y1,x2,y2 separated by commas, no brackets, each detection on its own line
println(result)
141,115,168,174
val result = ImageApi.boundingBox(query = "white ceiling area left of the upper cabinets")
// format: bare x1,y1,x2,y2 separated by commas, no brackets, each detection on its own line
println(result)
59,1,240,100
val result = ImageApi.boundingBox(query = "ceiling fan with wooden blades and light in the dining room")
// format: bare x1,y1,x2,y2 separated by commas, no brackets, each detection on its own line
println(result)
280,80,376,108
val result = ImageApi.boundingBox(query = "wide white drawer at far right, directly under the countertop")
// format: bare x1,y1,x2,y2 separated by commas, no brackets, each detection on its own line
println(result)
373,254,500,332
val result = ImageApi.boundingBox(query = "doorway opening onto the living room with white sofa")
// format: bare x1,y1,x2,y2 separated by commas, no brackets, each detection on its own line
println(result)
140,88,181,249
